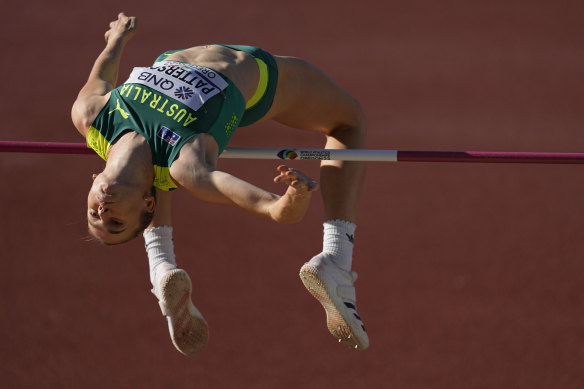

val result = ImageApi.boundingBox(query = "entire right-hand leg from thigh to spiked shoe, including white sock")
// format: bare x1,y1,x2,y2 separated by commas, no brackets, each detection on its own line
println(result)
265,57,369,349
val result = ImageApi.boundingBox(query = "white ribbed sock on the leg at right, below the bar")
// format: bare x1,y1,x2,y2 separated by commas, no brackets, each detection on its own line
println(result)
322,220,357,271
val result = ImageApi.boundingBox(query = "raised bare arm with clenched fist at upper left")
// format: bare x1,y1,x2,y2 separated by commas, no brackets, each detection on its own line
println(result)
71,12,137,136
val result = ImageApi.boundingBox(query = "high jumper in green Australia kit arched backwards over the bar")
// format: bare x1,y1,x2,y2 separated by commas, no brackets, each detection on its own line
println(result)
72,13,369,354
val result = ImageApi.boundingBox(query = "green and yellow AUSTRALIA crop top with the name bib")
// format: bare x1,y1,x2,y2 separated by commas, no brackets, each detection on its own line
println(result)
87,61,245,190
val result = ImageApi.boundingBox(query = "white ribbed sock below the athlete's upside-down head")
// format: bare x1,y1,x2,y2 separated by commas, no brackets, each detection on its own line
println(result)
143,226,177,286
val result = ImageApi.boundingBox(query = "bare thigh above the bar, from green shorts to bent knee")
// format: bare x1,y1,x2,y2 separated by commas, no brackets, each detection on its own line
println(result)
265,56,362,134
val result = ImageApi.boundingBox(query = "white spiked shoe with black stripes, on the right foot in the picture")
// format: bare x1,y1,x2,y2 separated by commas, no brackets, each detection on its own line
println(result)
300,253,369,350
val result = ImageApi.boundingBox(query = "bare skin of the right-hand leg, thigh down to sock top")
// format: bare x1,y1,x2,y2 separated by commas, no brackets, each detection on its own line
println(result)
265,56,366,222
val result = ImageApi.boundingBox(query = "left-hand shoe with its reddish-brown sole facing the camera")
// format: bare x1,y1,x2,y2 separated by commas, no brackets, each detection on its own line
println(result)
152,269,209,355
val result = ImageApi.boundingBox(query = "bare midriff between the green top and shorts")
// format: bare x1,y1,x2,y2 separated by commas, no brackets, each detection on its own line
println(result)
166,45,259,101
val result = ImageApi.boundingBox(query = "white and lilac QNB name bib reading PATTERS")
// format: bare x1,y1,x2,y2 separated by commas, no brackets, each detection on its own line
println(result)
126,61,228,111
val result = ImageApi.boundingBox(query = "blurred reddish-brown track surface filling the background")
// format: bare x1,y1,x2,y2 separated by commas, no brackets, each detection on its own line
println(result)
0,0,584,389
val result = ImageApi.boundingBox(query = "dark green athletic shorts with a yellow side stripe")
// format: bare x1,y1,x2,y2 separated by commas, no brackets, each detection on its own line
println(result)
155,45,278,127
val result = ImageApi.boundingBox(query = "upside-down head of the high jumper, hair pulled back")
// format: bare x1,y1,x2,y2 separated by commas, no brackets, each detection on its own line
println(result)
87,174,156,245
